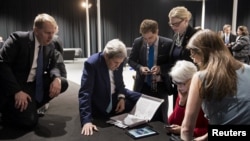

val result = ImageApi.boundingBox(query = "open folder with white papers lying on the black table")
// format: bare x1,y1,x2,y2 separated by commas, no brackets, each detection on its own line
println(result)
107,94,164,128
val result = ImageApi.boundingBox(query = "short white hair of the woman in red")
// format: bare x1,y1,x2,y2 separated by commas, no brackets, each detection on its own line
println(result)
169,60,197,83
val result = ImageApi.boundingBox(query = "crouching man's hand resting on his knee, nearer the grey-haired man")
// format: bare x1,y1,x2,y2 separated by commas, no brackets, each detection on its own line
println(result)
49,77,61,98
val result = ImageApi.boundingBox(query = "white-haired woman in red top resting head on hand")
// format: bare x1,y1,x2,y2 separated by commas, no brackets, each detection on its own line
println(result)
167,60,208,137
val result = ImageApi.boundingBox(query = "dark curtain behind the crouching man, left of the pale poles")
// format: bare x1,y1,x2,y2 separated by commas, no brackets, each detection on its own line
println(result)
0,0,92,56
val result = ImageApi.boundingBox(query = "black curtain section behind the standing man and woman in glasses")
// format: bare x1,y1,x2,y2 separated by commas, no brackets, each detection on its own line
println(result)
101,0,202,47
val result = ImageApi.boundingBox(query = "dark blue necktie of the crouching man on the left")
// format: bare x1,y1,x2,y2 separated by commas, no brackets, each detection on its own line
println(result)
36,46,43,102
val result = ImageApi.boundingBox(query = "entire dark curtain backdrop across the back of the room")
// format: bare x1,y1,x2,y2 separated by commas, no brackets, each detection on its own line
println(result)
0,0,250,57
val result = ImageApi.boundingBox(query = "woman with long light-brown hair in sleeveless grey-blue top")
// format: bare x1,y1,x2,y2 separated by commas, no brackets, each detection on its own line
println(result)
181,29,250,141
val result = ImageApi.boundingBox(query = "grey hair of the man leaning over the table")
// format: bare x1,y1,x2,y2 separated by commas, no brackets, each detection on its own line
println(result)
103,39,127,59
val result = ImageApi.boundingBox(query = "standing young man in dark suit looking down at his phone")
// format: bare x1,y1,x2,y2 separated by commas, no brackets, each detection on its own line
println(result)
128,19,172,122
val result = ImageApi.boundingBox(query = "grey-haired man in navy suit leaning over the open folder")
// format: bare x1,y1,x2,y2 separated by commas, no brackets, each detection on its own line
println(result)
79,39,141,135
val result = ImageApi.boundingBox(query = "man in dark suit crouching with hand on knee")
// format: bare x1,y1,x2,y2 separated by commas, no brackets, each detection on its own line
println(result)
0,14,68,129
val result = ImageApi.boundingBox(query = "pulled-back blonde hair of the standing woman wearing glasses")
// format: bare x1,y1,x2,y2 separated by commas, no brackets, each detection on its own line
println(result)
168,6,192,21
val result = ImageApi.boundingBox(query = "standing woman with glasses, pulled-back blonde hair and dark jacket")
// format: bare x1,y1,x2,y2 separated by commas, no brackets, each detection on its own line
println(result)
168,6,197,107
